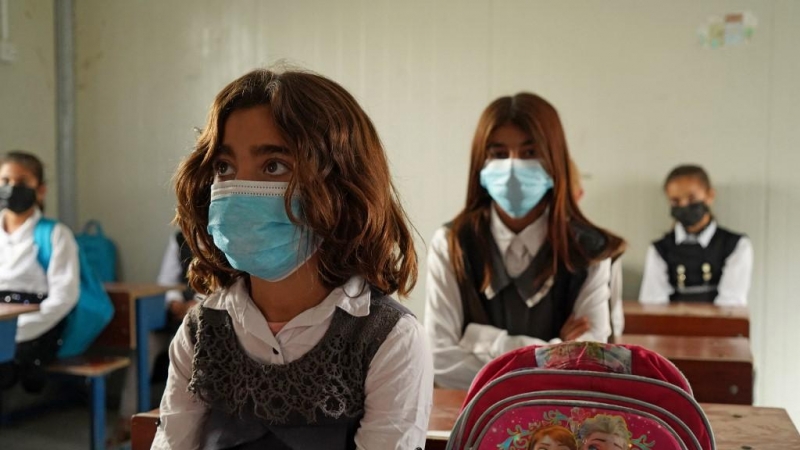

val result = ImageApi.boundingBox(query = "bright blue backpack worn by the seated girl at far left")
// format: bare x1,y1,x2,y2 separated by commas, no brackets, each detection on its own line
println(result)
33,218,114,358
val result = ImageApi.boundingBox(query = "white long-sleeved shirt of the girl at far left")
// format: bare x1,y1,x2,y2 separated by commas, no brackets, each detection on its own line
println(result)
0,208,80,342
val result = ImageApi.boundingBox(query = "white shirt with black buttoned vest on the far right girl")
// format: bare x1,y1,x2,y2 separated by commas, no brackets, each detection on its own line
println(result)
639,221,753,306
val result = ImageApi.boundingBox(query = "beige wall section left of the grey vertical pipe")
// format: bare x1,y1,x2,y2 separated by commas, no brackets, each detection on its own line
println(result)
0,0,58,217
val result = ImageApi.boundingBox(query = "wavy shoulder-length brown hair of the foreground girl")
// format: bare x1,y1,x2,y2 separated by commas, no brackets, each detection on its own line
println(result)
175,69,417,296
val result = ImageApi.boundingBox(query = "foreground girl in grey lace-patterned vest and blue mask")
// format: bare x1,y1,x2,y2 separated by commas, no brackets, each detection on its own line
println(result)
153,70,433,450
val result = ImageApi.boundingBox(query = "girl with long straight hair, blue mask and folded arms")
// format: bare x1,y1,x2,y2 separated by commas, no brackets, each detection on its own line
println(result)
425,93,621,389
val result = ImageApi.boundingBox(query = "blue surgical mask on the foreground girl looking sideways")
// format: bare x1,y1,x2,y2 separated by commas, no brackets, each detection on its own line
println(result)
208,181,318,281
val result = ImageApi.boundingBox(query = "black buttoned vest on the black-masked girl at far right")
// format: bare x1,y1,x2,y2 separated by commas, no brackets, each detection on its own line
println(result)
653,227,742,303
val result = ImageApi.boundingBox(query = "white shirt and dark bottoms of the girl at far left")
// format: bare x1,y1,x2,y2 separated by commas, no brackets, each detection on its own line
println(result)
0,209,80,388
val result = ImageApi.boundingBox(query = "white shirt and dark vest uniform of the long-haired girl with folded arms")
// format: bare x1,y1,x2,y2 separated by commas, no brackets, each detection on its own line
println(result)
425,209,611,389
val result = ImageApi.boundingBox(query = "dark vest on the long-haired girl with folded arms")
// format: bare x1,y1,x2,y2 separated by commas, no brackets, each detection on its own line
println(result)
459,221,606,341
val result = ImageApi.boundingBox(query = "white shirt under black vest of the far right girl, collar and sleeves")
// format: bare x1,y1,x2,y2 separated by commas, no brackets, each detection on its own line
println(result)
639,221,753,306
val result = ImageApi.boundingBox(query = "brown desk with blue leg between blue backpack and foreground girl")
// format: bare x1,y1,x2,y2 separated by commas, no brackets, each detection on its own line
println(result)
96,283,175,411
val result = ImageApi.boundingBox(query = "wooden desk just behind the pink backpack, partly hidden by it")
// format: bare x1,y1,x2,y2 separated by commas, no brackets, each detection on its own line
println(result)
617,334,753,405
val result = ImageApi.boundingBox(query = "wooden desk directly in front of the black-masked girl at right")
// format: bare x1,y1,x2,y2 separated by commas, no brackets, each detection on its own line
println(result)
622,301,750,337
